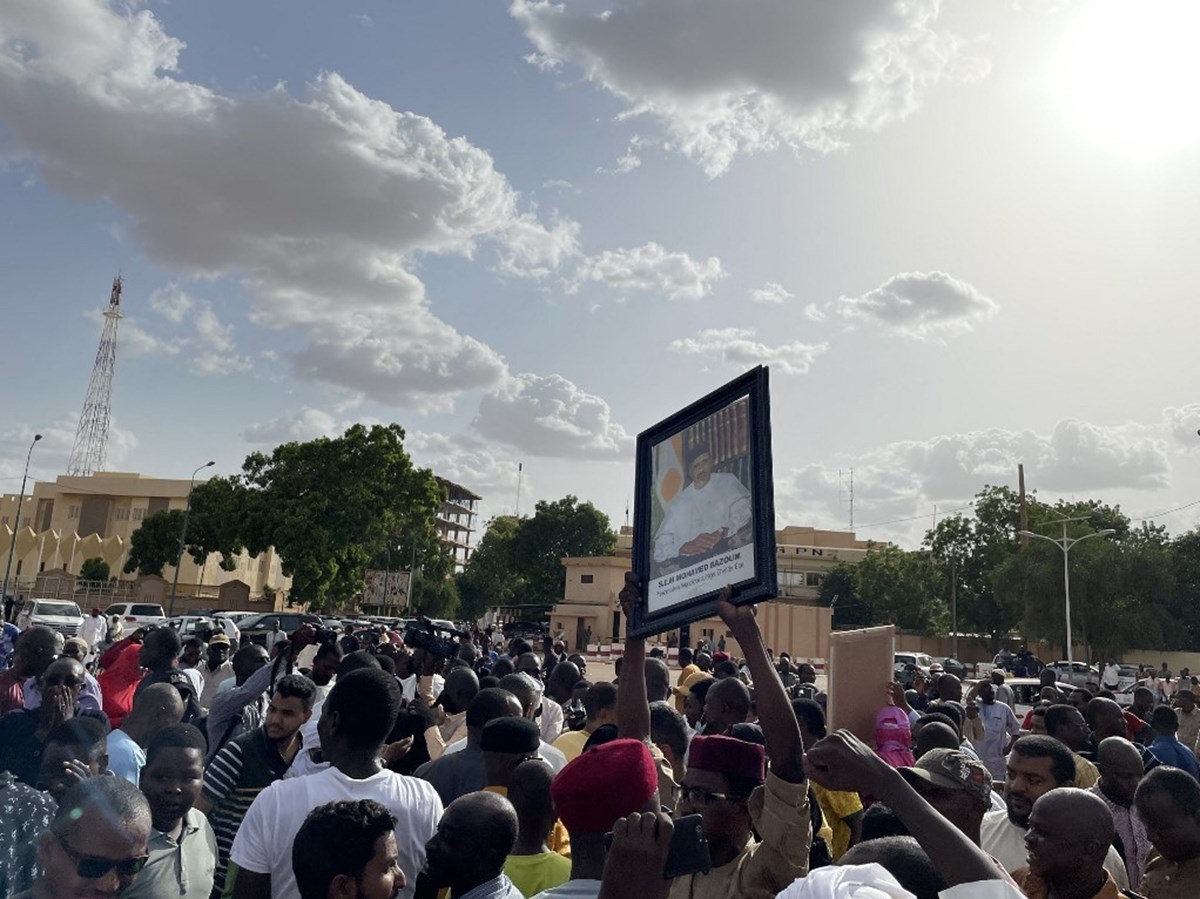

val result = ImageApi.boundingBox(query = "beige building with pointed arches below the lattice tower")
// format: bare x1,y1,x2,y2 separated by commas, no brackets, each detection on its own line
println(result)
0,472,292,615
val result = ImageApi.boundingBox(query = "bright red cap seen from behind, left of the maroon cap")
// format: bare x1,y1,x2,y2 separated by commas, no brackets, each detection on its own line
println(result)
550,739,659,835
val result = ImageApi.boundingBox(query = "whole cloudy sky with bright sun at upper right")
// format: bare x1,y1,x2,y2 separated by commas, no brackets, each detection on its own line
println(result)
0,0,1200,547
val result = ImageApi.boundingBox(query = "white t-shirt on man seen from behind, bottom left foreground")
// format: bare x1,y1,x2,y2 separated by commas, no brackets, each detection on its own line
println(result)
229,768,442,899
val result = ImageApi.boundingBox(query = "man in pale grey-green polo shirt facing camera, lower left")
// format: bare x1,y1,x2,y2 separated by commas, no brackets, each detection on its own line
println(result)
121,724,217,899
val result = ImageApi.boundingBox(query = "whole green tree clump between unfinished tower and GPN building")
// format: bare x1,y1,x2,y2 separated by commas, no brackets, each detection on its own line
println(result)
456,496,617,619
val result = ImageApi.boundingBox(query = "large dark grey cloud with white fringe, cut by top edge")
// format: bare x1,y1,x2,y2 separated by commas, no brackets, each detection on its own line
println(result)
509,0,988,176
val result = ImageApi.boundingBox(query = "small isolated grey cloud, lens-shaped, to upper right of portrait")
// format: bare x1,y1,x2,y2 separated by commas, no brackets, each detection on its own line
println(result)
835,271,1000,340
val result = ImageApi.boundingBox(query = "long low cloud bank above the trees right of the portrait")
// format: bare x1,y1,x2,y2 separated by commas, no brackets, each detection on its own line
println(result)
775,419,1171,538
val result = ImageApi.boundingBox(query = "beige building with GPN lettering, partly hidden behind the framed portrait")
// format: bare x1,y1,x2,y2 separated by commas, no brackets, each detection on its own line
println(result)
550,526,870,659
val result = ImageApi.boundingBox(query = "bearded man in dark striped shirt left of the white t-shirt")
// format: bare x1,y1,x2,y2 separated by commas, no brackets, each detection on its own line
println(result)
196,675,317,894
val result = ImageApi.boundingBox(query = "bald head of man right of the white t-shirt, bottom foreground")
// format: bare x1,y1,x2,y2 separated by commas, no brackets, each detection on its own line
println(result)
425,792,523,899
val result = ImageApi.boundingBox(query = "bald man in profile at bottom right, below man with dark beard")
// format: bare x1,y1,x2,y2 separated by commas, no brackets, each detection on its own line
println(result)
1013,787,1122,899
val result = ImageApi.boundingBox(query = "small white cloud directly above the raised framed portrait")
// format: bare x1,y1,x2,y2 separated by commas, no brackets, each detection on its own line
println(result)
569,241,725,300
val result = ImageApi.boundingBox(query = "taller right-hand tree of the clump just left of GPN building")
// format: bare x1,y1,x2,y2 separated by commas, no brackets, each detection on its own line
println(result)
514,496,617,605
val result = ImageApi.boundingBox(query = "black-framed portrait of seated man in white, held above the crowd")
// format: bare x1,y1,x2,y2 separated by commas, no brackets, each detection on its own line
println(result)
630,366,776,636
